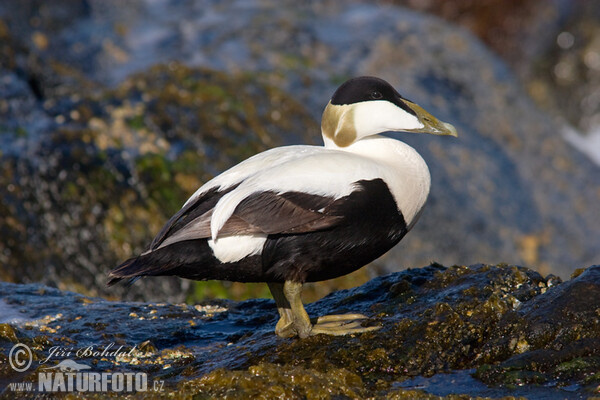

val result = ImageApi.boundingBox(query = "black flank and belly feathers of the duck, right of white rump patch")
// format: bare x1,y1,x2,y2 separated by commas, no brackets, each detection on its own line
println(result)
263,179,407,282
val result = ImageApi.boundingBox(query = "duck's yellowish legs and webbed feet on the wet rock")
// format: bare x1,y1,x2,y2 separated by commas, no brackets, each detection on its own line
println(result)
269,281,380,338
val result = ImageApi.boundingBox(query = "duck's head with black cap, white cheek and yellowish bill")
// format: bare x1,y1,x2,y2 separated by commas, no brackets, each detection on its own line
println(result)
321,76,457,147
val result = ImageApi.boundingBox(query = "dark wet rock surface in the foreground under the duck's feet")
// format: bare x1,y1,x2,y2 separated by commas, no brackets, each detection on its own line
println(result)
0,265,600,399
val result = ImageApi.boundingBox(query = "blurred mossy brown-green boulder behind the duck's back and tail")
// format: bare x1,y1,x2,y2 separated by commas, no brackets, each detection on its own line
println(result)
0,63,319,301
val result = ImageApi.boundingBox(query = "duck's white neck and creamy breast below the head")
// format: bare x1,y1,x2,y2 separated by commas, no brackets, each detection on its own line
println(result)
323,135,431,229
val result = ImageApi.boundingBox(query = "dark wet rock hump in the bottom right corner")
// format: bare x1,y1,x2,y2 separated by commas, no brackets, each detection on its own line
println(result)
477,267,600,385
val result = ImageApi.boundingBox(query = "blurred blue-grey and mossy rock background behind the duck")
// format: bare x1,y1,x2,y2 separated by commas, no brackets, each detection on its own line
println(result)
0,0,600,302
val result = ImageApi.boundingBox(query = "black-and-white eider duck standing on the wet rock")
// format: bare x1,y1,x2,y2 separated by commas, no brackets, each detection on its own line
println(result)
108,77,457,338
